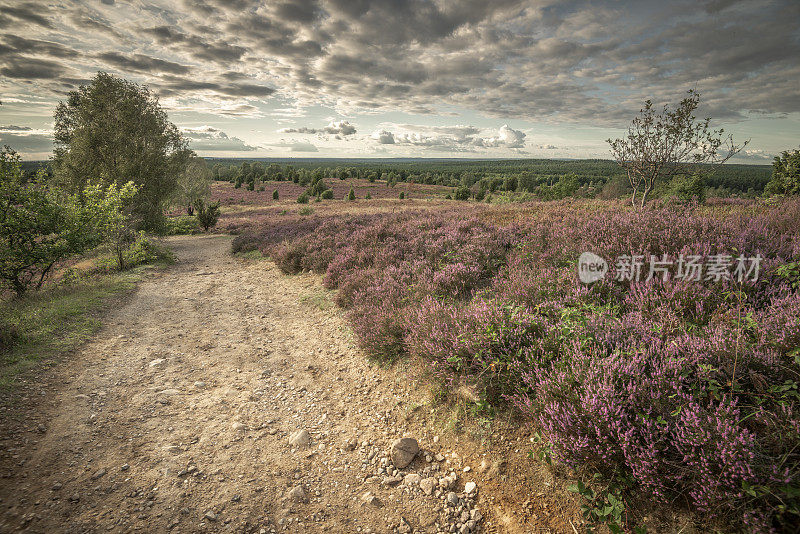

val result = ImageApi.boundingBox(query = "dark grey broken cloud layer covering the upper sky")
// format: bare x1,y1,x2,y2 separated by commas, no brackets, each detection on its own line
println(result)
0,0,800,129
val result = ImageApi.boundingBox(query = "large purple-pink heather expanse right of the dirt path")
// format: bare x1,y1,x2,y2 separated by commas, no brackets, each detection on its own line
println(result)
237,200,800,532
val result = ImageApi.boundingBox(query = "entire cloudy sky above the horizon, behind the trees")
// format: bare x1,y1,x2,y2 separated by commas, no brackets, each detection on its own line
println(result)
0,0,800,164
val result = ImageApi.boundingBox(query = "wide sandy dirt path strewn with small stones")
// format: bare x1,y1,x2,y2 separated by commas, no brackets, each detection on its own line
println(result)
0,236,580,533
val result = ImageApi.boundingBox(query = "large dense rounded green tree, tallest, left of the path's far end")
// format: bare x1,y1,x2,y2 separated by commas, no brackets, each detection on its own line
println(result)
53,72,193,230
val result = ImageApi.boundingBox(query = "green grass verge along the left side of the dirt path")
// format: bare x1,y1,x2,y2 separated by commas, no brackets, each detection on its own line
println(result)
0,265,163,390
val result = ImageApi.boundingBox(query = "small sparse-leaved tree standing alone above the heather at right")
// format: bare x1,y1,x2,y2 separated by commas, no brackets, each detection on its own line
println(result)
607,90,749,207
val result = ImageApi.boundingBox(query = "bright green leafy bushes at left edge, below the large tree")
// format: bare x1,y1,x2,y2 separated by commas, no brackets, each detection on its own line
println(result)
0,148,137,296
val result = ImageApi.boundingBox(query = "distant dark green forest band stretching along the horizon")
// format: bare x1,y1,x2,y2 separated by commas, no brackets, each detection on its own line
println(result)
207,158,772,200
